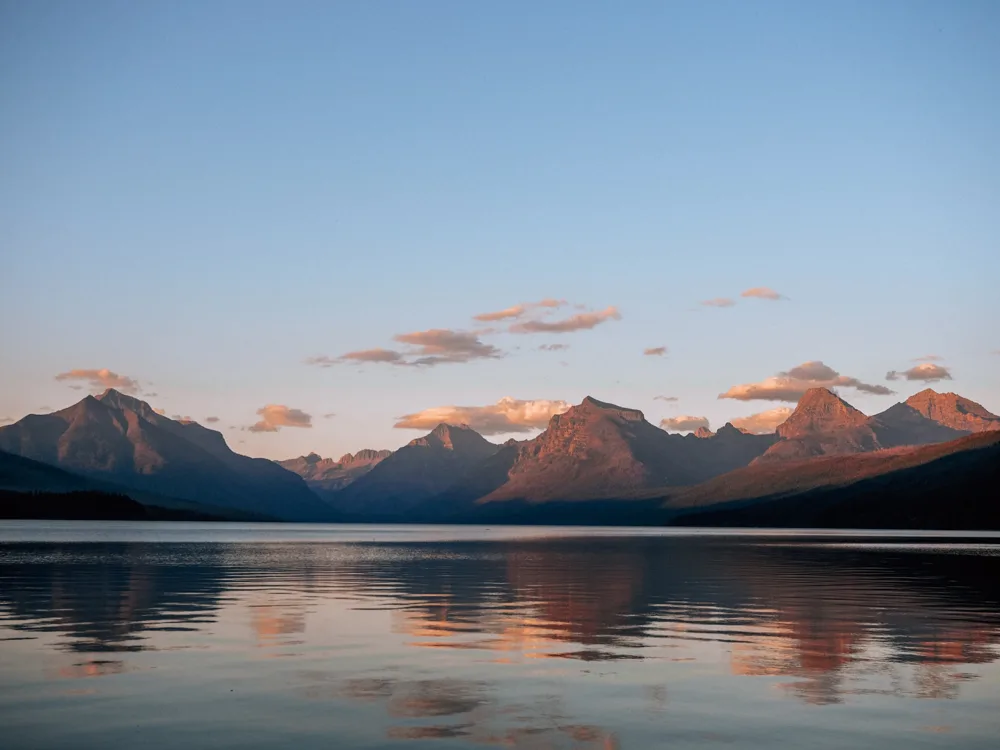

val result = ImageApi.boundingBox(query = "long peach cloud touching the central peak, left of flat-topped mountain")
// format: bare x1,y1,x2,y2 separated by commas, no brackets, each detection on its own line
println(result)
393,396,570,435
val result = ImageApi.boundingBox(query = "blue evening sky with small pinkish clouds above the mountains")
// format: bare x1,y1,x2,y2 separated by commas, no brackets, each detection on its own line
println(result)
0,0,1000,458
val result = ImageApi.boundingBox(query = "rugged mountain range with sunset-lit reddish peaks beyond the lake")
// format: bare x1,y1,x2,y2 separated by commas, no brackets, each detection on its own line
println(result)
0,388,1000,525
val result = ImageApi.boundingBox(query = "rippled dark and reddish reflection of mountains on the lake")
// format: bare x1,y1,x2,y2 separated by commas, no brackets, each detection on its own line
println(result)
0,537,1000,716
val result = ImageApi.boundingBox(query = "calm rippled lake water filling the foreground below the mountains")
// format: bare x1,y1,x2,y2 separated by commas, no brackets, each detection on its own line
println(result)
0,522,1000,750
